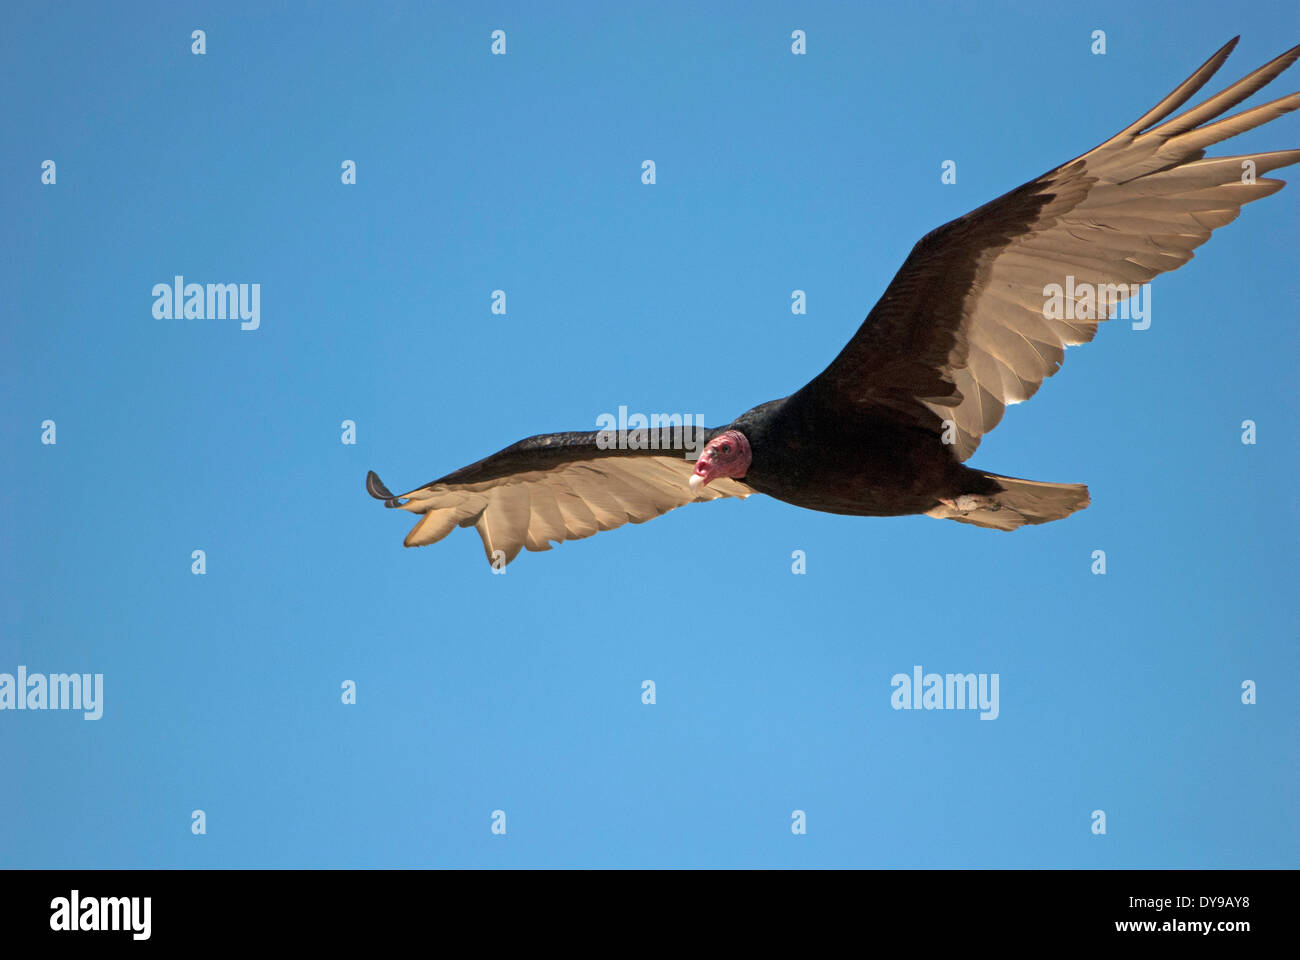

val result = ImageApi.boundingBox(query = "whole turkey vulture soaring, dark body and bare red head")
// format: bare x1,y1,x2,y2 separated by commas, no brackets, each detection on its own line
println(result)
365,38,1300,567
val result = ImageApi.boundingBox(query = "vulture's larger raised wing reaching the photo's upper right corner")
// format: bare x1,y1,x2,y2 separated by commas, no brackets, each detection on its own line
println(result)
803,38,1300,459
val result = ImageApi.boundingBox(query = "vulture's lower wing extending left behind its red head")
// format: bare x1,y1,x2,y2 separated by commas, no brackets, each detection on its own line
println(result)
365,428,754,565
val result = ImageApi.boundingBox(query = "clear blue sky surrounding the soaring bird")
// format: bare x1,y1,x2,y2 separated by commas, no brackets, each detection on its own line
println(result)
0,0,1300,868
